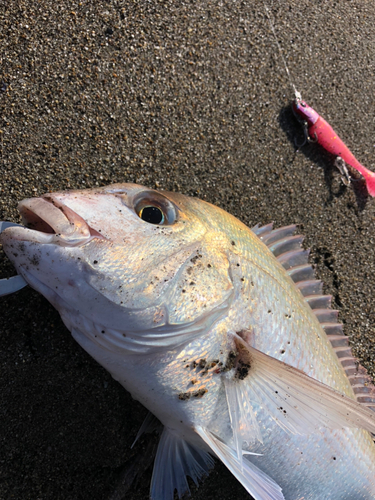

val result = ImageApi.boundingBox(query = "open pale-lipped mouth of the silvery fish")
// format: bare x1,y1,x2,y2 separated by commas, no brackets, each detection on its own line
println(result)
2,195,106,246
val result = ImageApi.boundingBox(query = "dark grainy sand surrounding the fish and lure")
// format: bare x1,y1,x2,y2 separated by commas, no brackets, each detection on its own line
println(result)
0,0,375,500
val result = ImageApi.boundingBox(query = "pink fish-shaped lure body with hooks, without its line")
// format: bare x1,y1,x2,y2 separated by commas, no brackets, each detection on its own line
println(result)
292,98,375,196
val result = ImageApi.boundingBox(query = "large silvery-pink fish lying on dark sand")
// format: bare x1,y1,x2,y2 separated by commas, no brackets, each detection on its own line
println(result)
0,184,375,500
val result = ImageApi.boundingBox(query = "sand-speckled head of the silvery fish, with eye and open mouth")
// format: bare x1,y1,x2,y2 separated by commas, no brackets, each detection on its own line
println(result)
0,184,233,353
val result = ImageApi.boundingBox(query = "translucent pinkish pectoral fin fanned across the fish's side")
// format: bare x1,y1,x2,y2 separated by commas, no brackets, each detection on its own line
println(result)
231,334,375,434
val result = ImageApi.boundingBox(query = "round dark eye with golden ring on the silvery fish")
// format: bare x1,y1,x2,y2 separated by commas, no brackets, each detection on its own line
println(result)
133,191,178,226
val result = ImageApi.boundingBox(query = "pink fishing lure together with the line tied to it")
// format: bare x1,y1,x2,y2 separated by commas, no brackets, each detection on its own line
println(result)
264,5,375,196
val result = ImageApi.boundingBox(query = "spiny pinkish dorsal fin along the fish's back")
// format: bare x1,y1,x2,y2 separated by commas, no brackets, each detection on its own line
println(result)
252,224,375,411
